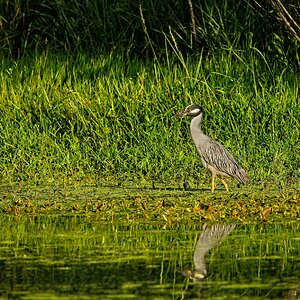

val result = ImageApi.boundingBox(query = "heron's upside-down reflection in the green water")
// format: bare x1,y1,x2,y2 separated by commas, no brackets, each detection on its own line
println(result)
180,224,235,281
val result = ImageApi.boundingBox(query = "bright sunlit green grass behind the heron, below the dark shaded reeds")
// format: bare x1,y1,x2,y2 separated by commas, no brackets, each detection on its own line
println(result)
0,49,300,183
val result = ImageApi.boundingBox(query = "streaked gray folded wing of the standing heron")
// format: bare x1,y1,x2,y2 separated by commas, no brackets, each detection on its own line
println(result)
201,138,249,183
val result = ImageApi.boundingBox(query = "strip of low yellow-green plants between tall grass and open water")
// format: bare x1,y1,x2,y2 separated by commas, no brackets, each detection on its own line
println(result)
0,183,300,223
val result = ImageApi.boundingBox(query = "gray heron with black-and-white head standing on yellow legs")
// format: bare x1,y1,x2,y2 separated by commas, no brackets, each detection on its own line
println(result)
174,104,249,192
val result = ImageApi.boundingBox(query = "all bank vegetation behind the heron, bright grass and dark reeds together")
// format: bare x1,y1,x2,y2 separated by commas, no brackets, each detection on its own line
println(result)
0,0,300,186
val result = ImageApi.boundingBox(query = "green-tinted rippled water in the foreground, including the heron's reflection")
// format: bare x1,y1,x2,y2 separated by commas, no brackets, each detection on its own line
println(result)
0,216,300,299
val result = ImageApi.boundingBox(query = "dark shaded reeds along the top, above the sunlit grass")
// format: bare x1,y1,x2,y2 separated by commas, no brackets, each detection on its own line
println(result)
0,0,300,61
